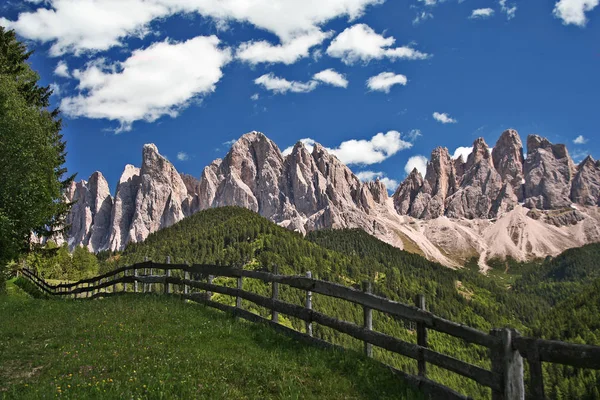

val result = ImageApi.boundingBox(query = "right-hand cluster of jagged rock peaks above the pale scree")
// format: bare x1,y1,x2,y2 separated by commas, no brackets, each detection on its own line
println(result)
394,129,600,219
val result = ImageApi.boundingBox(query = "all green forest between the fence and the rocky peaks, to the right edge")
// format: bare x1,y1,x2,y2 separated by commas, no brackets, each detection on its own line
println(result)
17,207,600,399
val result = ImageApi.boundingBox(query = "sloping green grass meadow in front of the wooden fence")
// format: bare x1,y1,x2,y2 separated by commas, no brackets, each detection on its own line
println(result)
0,282,422,399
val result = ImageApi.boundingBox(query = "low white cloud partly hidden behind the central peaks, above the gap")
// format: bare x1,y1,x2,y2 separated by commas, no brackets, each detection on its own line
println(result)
283,131,412,165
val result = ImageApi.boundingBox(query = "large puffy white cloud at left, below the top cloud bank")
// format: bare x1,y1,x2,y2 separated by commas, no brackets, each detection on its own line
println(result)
60,36,231,131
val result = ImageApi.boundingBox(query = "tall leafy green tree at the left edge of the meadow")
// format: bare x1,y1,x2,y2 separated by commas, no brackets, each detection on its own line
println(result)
0,27,72,265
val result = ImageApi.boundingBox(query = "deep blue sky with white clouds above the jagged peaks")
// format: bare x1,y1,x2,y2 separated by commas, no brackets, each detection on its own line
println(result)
0,0,600,191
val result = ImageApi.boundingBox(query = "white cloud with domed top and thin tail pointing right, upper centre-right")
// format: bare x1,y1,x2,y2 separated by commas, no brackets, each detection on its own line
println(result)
327,24,430,64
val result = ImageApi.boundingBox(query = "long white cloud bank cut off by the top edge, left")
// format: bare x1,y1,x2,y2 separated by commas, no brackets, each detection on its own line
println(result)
0,0,383,56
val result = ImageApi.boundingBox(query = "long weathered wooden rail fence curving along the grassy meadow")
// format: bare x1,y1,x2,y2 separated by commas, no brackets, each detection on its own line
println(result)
22,259,600,400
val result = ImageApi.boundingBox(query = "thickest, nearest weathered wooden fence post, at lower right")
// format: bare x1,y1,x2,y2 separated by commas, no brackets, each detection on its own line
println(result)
490,328,525,400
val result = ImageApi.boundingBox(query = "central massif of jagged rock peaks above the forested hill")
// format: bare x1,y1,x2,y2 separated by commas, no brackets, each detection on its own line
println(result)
200,132,387,233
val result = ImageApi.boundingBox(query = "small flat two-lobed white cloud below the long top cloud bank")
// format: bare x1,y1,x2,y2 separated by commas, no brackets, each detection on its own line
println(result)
254,68,348,94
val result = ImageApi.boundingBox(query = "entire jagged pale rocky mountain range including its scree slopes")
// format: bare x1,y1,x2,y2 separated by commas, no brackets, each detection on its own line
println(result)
56,130,600,270
